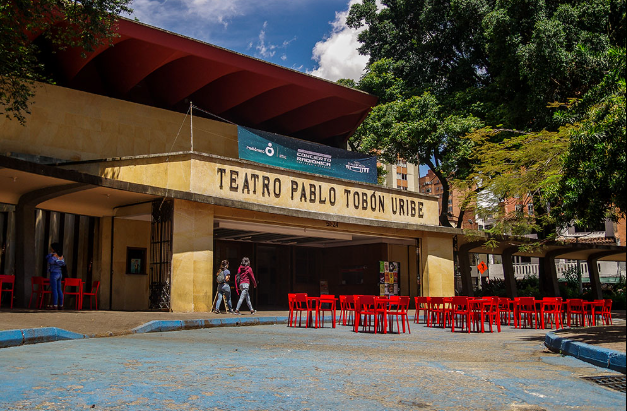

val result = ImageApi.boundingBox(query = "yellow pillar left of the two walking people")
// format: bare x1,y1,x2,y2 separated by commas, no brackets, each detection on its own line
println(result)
170,200,214,312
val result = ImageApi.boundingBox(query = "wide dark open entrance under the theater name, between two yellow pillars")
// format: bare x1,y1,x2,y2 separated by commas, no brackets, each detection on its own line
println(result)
214,219,417,310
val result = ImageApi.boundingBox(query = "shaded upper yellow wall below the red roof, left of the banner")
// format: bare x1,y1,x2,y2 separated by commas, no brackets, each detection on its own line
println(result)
0,84,238,161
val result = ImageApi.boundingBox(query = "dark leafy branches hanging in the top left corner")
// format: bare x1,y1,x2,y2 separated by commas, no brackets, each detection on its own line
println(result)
0,0,132,124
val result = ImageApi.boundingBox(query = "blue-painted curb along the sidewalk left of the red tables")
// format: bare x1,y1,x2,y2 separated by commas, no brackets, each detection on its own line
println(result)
0,317,287,348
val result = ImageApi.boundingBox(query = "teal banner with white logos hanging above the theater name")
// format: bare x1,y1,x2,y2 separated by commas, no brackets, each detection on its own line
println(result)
237,126,377,184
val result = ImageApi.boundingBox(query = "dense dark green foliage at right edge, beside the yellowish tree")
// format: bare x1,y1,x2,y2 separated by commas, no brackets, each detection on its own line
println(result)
552,48,627,226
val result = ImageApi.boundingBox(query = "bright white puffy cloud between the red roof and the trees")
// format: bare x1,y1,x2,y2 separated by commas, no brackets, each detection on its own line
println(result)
309,0,368,81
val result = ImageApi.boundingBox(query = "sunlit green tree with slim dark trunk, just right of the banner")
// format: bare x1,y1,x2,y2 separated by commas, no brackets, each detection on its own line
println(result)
350,60,482,227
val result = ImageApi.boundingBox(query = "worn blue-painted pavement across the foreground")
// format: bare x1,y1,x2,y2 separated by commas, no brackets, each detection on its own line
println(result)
0,324,626,410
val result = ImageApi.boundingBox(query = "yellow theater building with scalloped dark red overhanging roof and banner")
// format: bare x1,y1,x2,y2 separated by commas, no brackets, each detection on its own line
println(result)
0,20,458,312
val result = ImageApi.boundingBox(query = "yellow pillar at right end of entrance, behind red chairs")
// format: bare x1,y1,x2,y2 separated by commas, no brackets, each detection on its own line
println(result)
421,237,455,297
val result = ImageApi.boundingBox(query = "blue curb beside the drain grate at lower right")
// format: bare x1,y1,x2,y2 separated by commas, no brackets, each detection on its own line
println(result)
544,332,626,374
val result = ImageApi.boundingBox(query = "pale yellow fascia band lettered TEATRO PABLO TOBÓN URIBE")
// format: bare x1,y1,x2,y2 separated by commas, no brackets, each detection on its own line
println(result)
75,154,439,226
